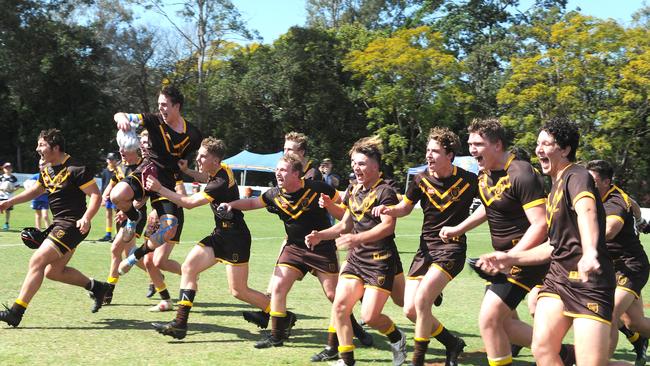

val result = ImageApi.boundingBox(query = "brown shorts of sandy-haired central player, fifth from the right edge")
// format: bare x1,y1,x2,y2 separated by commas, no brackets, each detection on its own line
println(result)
341,251,399,293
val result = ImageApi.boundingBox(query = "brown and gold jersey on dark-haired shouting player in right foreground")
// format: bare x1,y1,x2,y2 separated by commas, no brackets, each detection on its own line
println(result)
546,164,613,276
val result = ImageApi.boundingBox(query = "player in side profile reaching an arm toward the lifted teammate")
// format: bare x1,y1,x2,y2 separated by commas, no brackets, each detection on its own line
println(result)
146,137,269,339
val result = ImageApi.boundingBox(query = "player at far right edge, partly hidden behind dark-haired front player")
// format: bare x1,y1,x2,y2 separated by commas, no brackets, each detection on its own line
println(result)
587,160,650,365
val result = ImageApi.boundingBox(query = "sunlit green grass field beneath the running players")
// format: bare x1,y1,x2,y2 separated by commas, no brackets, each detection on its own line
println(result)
0,193,650,365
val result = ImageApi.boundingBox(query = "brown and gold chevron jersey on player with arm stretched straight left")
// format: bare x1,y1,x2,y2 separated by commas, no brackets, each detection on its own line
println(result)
260,179,338,248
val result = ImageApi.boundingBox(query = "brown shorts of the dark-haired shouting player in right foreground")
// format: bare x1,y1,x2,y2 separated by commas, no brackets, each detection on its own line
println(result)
537,266,614,324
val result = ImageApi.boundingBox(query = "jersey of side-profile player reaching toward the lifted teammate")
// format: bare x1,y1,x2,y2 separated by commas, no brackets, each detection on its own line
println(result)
202,163,245,229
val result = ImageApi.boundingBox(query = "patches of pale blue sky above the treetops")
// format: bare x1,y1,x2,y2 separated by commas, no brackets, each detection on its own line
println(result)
233,0,643,43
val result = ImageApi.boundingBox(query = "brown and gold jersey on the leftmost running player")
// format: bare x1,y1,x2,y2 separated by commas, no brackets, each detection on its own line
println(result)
38,155,96,220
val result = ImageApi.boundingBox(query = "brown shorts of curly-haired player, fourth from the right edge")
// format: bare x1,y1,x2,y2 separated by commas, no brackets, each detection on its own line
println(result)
406,247,465,281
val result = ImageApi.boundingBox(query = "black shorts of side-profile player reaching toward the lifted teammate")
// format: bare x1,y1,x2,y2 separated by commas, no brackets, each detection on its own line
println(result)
198,224,251,265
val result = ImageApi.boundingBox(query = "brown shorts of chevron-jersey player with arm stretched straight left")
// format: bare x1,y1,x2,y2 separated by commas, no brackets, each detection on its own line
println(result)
276,243,339,276
